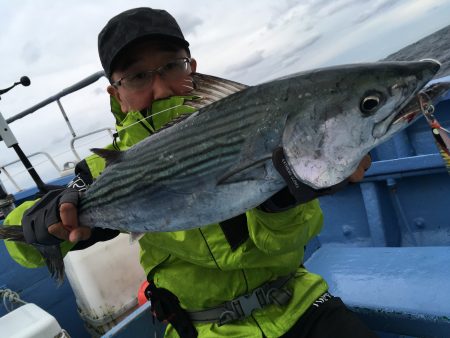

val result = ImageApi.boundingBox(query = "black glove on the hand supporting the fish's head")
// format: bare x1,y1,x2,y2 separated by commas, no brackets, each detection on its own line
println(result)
259,147,348,212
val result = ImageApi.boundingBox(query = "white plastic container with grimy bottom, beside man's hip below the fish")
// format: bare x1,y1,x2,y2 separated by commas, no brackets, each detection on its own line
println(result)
64,234,146,336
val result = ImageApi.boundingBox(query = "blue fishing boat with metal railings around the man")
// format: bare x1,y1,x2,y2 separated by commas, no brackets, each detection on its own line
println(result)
0,30,450,338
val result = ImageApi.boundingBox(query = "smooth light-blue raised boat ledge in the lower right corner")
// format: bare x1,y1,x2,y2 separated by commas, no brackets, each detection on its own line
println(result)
306,245,450,337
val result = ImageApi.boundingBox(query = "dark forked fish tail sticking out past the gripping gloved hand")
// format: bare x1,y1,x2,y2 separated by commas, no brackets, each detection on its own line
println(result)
0,225,64,285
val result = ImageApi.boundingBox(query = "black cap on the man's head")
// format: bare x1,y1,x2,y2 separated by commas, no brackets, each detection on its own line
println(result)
98,7,189,78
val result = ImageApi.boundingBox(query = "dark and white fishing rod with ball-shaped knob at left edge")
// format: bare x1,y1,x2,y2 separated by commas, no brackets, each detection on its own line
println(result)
0,76,49,193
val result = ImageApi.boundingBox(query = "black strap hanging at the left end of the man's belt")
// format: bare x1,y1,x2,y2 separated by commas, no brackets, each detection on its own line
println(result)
144,281,198,338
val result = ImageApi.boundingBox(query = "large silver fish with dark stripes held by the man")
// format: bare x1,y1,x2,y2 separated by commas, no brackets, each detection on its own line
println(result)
0,60,444,282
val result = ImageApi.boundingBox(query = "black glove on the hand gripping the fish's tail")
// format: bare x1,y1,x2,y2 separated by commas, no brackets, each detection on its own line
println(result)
22,188,79,245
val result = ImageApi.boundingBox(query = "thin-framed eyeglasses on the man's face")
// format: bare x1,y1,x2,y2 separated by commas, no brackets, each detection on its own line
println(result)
112,58,191,89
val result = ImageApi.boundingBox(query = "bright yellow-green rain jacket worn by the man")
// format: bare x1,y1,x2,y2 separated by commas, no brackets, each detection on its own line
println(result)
4,97,328,338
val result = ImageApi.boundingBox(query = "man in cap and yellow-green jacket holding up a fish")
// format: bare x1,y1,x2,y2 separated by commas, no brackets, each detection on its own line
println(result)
5,8,375,338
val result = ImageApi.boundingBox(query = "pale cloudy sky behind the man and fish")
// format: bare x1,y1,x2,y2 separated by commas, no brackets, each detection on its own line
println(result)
0,0,450,192
